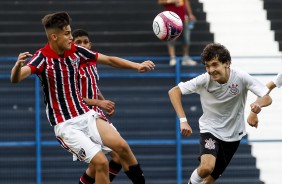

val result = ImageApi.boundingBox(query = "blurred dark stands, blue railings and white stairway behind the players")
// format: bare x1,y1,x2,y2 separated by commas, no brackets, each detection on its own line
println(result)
0,0,282,184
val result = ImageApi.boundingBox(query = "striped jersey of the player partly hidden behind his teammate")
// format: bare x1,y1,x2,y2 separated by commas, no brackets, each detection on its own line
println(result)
79,63,111,123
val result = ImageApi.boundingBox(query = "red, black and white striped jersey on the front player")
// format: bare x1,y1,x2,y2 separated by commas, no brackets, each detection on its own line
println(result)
27,44,98,125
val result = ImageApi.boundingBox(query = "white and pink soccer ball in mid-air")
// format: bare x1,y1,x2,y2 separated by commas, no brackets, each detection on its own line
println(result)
153,11,183,41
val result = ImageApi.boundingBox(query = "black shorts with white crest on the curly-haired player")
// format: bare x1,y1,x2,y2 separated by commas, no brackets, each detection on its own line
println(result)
200,133,240,180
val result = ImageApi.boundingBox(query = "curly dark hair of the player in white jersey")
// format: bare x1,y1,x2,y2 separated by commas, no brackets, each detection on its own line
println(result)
201,43,231,64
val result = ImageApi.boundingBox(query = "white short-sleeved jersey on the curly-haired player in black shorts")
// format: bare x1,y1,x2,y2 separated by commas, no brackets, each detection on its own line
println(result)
178,68,268,142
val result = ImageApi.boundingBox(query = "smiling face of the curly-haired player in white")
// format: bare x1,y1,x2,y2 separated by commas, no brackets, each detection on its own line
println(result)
205,58,230,84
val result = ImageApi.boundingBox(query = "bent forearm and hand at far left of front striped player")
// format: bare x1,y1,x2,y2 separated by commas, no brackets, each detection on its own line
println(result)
11,52,32,83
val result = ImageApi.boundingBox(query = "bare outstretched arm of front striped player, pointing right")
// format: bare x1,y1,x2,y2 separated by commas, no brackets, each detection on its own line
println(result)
97,53,155,73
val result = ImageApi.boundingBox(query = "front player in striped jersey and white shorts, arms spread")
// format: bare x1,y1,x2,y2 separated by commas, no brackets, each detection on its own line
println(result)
11,12,155,184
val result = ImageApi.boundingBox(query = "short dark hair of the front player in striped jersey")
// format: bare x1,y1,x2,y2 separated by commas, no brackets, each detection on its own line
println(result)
42,12,71,30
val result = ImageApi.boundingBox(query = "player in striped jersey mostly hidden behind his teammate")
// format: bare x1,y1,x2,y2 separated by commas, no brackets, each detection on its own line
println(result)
72,29,122,182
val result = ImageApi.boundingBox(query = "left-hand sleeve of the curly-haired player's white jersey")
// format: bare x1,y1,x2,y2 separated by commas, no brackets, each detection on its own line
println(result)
178,73,208,95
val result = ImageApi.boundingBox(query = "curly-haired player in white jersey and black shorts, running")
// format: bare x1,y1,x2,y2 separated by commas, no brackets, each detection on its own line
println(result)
169,43,272,184
